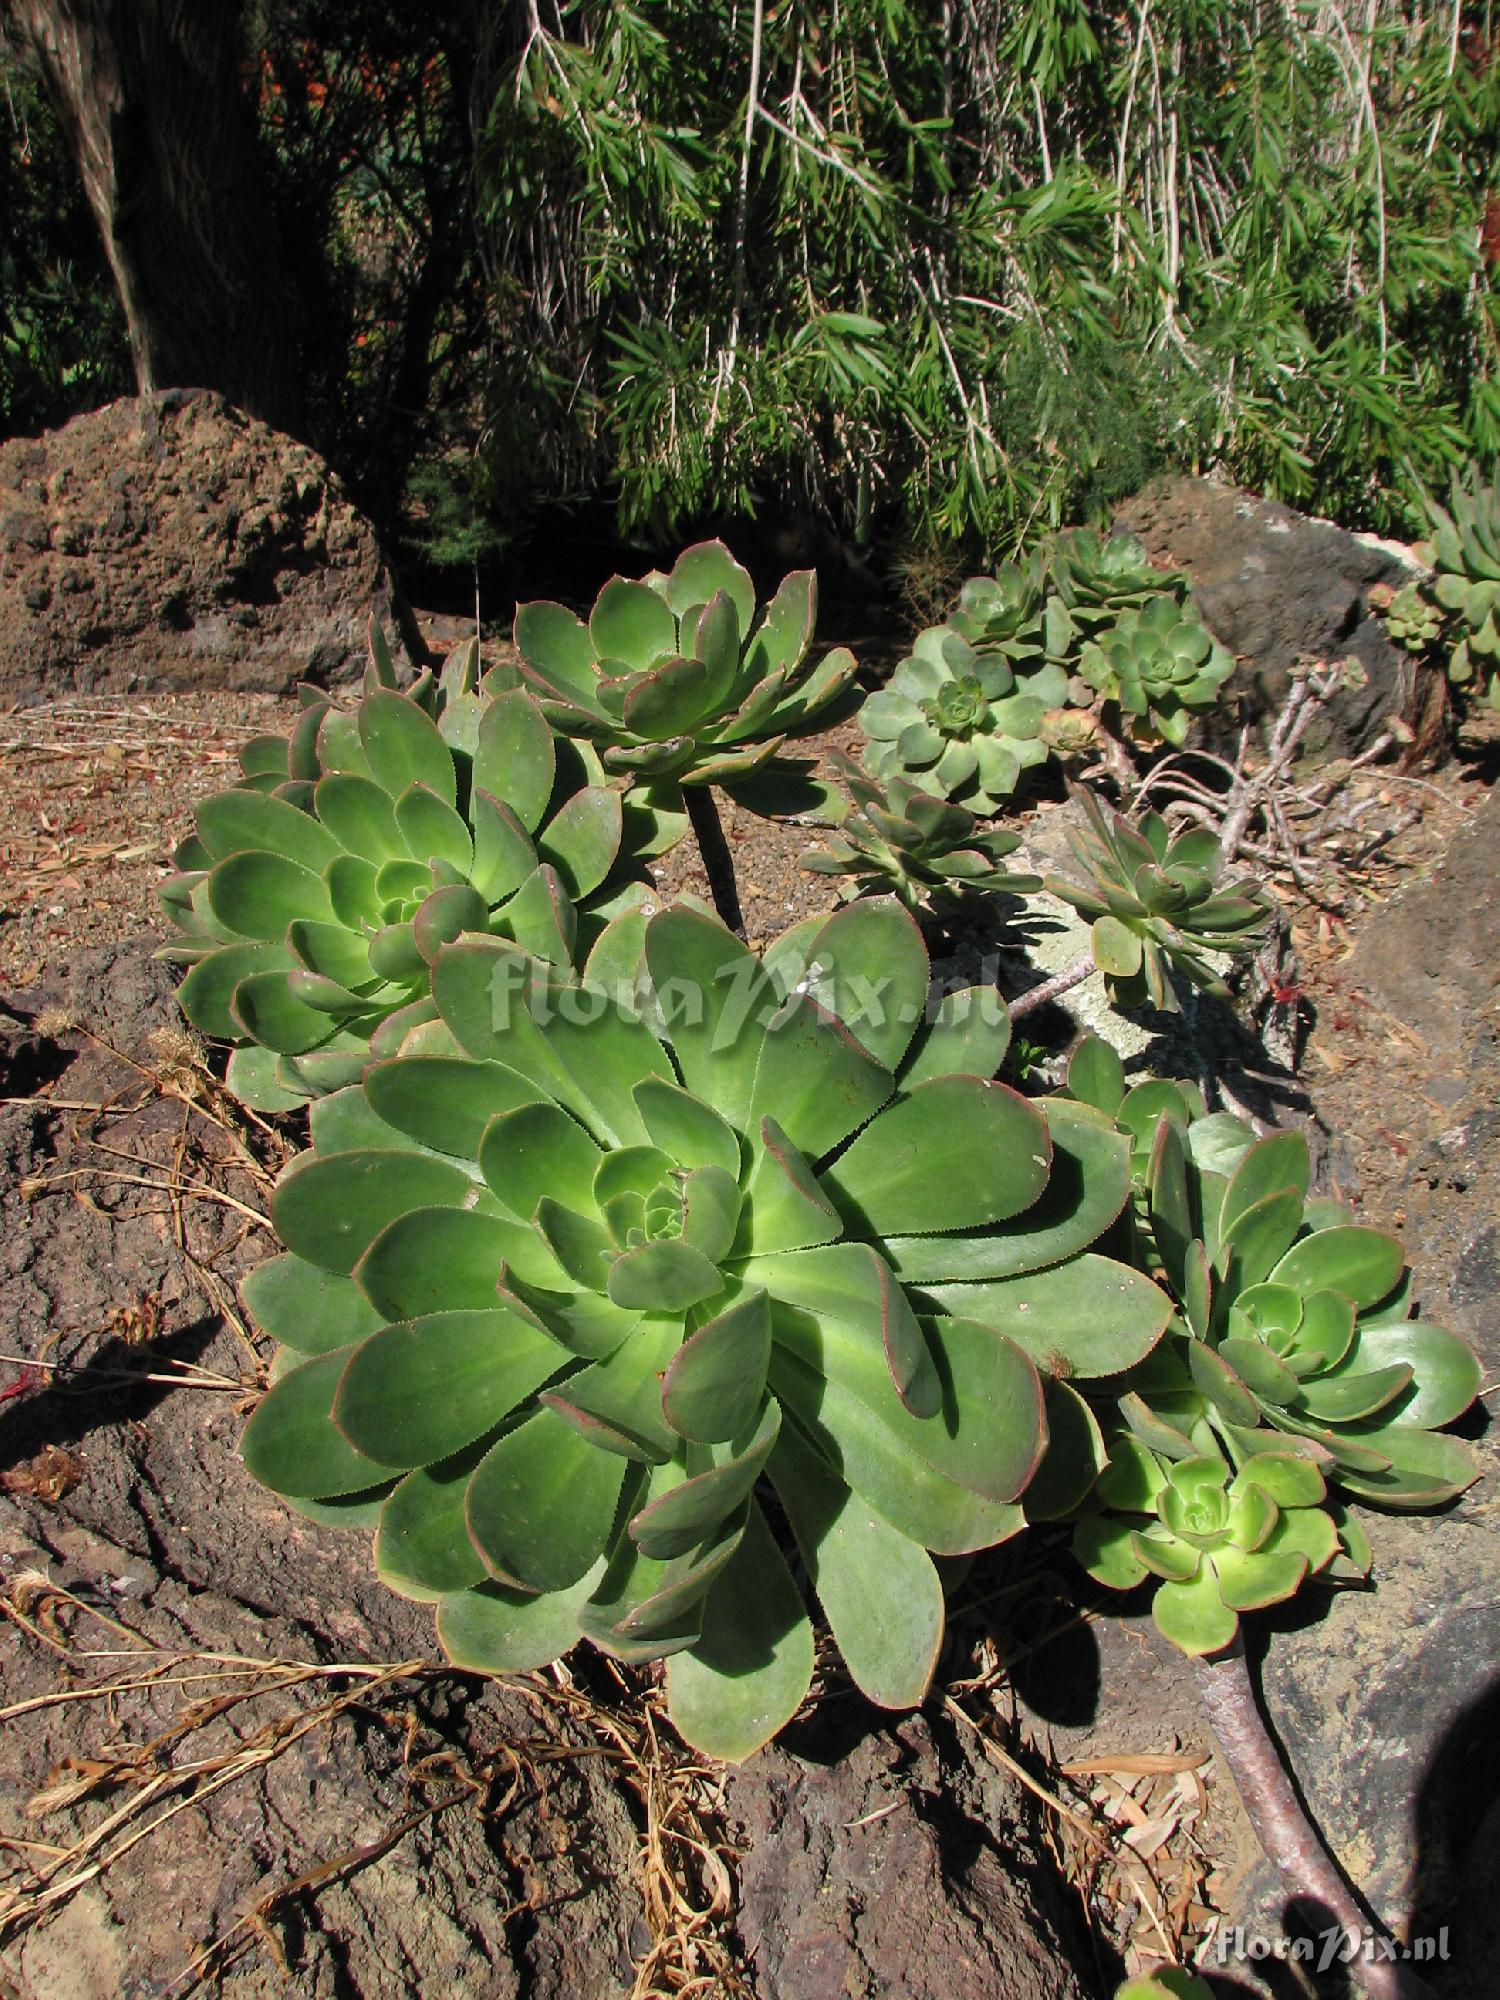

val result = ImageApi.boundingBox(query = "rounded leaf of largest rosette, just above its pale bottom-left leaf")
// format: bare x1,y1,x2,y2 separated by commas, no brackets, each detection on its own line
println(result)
468,1410,626,1590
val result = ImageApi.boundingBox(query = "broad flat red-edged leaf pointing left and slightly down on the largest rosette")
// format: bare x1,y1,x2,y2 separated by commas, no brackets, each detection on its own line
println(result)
334,1302,568,1468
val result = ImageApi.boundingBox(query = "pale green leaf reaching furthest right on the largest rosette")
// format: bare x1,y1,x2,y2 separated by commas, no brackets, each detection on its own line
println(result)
922,1254,1176,1384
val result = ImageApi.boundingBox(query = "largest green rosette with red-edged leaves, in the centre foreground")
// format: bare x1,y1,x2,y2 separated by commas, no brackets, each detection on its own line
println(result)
244,902,1170,1758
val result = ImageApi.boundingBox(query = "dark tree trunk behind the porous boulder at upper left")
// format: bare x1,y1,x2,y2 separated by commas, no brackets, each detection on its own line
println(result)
4,0,300,432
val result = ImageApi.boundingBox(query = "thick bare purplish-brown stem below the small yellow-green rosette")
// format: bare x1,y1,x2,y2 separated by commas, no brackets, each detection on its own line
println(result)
1192,1638,1436,2000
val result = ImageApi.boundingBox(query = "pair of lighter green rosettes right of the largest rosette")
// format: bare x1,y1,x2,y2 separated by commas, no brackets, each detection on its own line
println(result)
1070,1040,1480,1654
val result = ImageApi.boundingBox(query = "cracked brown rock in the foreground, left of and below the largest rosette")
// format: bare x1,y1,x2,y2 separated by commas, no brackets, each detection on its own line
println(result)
0,938,1092,2000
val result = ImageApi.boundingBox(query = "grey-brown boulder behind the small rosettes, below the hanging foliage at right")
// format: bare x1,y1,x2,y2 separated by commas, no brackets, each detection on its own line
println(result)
1114,476,1444,756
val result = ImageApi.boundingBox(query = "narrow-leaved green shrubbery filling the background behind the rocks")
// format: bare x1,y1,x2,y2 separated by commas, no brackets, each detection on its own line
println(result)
0,0,1500,578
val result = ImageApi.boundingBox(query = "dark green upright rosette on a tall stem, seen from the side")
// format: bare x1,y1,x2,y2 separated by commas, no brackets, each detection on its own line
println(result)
516,542,856,786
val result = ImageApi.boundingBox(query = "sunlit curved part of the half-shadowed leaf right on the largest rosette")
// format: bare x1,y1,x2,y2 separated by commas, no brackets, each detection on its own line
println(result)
884,1098,1130,1286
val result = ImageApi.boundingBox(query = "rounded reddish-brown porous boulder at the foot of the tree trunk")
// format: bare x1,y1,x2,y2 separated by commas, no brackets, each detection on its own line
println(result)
0,390,418,696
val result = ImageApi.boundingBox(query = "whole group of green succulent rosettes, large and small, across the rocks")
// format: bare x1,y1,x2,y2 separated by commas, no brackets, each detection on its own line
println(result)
164,536,1478,1784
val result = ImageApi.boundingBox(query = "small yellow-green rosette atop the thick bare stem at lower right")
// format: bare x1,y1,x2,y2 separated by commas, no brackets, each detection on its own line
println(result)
1074,1434,1340,1654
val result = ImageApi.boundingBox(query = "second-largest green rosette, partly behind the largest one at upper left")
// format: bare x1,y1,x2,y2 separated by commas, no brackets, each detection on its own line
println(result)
162,648,676,1110
